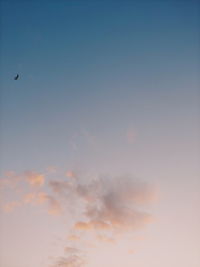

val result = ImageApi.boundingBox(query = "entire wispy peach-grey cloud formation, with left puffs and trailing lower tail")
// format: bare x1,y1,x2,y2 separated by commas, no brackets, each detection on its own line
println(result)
2,170,155,267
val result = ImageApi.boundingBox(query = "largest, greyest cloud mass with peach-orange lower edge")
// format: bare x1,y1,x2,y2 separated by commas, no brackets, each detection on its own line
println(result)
66,176,154,231
